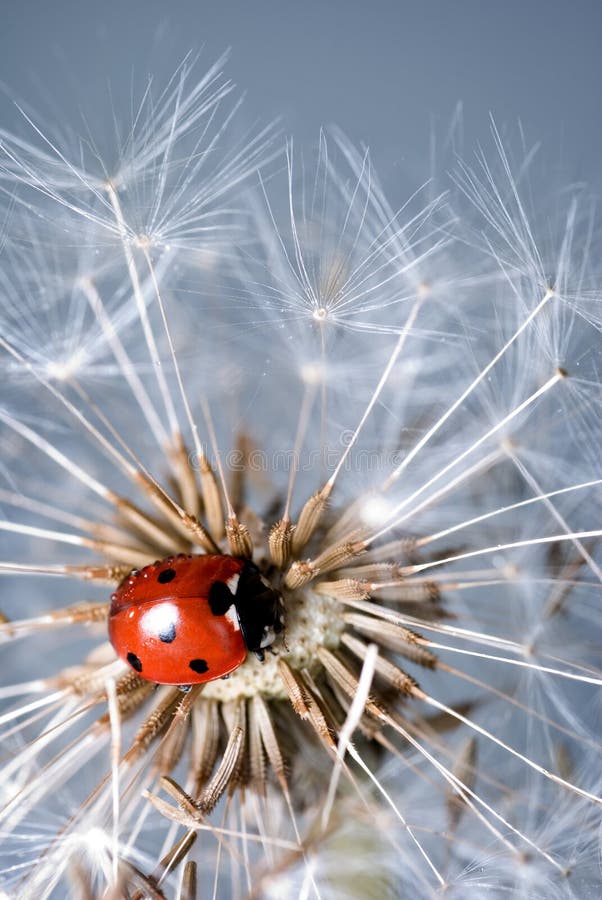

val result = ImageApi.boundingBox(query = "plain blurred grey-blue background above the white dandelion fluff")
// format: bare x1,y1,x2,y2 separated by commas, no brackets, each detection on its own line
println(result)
0,0,602,189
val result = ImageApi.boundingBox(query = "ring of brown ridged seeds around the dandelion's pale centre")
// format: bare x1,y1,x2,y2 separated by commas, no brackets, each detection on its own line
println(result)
10,412,596,898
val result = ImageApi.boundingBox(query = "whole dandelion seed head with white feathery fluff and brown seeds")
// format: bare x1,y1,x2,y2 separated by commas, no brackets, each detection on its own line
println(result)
0,61,602,898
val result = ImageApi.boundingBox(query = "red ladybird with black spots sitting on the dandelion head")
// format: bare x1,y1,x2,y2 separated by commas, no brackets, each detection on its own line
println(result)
109,555,283,686
